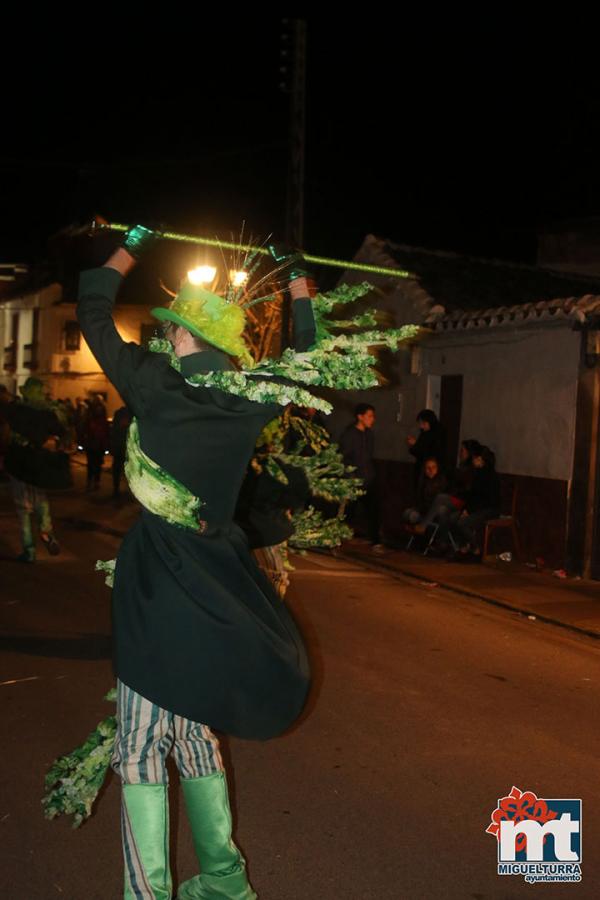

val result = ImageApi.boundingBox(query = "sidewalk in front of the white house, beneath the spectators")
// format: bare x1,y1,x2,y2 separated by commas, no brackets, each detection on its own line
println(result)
333,539,600,640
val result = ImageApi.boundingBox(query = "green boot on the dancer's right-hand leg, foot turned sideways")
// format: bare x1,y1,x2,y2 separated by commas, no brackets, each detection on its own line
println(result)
177,772,257,900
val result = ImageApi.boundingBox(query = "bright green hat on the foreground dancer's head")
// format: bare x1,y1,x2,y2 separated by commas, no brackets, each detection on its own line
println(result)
151,284,254,366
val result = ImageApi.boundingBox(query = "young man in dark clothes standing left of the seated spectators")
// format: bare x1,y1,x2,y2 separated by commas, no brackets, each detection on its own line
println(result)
339,403,384,553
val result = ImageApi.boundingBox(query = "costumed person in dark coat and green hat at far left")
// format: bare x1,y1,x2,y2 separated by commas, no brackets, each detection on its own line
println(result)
4,378,71,563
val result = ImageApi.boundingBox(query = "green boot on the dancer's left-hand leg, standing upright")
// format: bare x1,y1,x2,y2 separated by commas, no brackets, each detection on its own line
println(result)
121,784,173,900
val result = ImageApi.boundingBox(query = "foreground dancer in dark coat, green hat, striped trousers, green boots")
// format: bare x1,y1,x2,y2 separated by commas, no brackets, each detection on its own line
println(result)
77,226,315,900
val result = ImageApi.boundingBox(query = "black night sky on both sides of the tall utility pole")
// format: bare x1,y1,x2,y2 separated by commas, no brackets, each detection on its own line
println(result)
0,19,600,262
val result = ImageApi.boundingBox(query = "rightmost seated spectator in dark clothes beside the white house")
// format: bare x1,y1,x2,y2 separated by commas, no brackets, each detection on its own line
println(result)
449,446,500,560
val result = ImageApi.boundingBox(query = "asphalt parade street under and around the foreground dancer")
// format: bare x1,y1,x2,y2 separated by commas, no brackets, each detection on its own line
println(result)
0,484,600,900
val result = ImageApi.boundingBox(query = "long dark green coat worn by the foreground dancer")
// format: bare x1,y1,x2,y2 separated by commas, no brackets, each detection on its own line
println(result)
78,268,310,739
